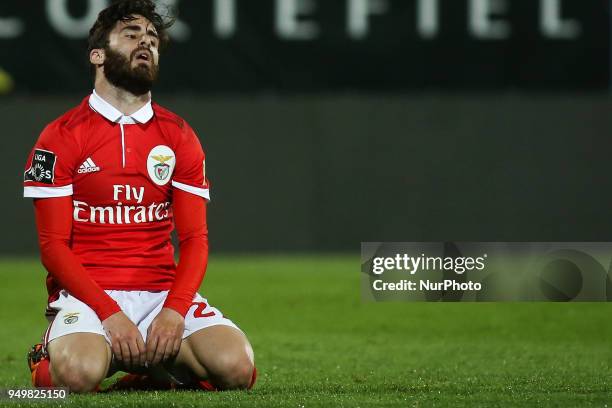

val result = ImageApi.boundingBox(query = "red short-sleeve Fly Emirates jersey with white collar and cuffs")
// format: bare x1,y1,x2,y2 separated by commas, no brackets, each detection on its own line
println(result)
24,91,210,290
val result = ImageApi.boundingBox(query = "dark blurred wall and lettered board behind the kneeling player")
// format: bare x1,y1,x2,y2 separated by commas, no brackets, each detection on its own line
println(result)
0,0,612,254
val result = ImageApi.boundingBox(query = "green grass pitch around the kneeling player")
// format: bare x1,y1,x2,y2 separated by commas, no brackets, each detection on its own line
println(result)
0,255,612,408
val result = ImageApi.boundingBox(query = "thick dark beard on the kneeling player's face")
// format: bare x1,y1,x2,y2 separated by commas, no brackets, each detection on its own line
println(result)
104,45,159,95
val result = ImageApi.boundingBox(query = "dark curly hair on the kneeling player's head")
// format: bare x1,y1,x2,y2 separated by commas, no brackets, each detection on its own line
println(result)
87,0,176,72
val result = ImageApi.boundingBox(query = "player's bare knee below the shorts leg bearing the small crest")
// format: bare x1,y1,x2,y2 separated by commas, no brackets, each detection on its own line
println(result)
50,355,107,392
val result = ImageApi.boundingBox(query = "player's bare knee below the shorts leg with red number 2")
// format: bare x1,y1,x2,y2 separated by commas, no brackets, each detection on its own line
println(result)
210,354,255,390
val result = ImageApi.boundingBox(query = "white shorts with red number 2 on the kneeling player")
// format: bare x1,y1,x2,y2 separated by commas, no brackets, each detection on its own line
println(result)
43,290,240,346
